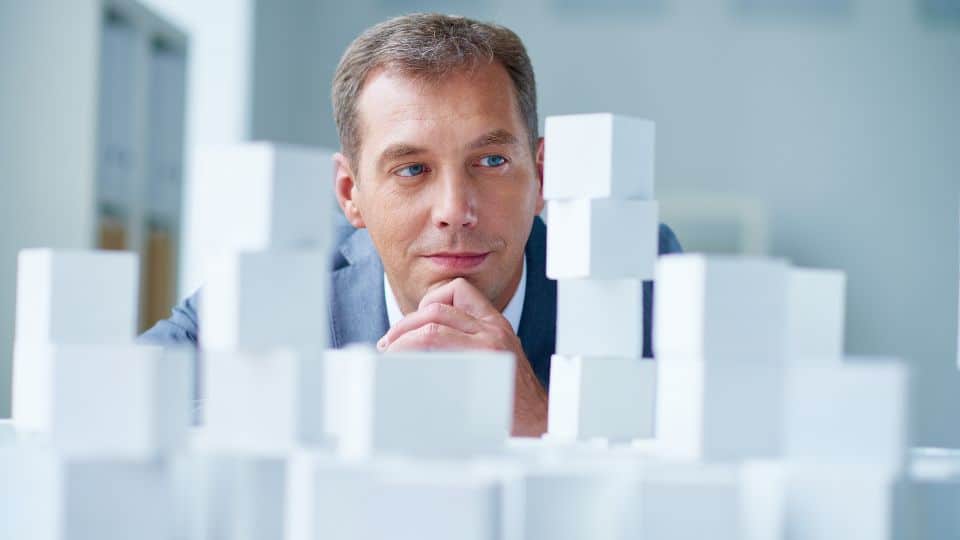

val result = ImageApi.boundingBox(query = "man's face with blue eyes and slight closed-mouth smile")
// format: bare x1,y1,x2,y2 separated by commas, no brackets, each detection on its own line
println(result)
337,63,543,313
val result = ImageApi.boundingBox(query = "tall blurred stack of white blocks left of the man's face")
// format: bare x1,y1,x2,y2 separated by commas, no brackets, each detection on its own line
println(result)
186,143,333,540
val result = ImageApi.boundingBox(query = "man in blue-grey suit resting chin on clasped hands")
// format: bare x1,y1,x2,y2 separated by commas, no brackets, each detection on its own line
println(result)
142,14,680,436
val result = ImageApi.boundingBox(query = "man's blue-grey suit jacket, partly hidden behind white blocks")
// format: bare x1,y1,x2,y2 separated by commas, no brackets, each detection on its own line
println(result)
140,217,681,388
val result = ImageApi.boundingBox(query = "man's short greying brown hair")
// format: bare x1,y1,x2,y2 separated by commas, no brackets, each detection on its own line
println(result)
331,13,539,164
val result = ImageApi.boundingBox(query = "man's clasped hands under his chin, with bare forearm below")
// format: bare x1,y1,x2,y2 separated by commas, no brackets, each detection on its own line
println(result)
377,278,547,437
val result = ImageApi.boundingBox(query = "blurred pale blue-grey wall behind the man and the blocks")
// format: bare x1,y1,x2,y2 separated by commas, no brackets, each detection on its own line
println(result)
0,0,960,445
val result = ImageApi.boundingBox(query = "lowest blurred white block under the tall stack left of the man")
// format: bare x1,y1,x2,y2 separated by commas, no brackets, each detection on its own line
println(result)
172,452,288,540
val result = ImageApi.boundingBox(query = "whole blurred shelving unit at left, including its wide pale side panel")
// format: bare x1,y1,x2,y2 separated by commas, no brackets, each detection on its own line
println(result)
0,0,188,417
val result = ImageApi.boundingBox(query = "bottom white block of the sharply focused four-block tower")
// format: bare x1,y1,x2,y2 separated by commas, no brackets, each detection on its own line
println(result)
548,355,657,441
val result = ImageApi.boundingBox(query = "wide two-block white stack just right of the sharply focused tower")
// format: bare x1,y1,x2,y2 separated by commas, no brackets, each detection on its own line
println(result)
654,255,789,461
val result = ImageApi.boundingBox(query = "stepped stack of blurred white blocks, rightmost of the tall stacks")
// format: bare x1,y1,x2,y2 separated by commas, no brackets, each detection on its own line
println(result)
768,269,913,540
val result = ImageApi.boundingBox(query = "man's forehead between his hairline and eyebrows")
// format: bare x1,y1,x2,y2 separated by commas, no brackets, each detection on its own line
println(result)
357,63,525,160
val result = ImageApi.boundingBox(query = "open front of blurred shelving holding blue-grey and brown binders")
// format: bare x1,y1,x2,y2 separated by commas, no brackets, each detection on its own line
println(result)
95,1,187,328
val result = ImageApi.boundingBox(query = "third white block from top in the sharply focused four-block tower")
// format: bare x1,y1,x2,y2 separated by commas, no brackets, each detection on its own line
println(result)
556,279,643,358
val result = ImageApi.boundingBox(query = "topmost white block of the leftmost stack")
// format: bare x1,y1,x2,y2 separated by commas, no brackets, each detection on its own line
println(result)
16,249,140,344
